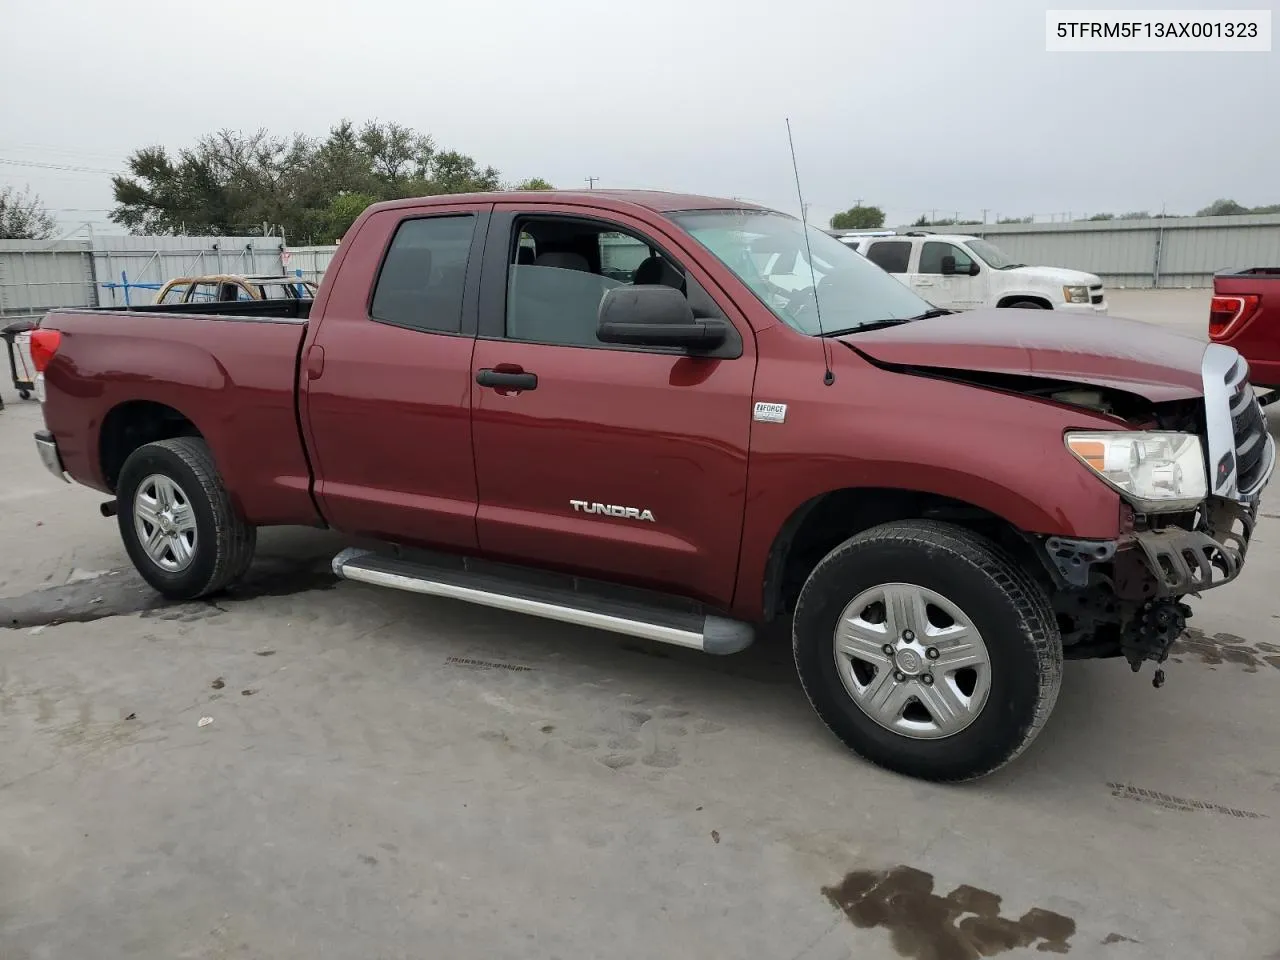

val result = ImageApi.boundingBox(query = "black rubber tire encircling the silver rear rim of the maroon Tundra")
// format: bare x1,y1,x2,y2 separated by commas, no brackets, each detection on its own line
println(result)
115,436,257,600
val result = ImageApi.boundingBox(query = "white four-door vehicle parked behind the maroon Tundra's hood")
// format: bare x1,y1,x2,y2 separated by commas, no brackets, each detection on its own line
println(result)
838,232,1107,314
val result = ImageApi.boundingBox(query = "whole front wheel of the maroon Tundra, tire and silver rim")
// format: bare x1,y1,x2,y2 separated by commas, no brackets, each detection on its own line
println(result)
792,521,1062,781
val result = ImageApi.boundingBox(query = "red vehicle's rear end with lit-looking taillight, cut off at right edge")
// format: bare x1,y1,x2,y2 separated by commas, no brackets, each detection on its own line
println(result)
1208,266,1280,388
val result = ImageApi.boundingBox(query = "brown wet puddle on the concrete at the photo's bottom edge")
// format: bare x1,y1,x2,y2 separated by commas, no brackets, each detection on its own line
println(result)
822,867,1075,960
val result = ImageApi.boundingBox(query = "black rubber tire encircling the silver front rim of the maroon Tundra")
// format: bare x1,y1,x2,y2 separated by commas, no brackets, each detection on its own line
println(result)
792,520,1062,782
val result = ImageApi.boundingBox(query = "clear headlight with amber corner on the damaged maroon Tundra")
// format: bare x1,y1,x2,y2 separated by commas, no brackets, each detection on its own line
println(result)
1066,431,1208,513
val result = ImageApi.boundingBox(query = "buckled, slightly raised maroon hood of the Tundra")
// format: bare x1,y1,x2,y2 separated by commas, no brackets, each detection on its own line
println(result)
838,307,1207,403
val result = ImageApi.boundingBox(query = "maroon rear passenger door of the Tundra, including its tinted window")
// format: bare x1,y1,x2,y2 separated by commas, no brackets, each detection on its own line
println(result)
302,204,490,549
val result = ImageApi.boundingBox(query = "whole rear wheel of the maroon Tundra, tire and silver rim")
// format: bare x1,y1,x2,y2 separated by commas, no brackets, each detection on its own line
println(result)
115,436,257,600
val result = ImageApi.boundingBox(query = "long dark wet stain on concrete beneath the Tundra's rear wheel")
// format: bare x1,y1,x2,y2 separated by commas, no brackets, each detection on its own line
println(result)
0,556,338,630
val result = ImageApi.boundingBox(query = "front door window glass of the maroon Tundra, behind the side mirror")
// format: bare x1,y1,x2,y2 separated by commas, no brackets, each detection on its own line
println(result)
506,218,689,348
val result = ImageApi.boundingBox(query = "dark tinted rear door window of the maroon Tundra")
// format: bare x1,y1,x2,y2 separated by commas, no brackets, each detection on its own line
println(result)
369,214,476,333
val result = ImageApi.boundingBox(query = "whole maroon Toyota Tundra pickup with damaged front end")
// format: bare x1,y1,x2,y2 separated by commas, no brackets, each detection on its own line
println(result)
24,191,1275,781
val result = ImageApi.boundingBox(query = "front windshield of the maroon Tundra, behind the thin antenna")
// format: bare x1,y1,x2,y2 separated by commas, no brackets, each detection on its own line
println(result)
672,210,932,337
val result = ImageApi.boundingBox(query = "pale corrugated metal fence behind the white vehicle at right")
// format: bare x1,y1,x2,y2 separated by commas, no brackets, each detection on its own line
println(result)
834,214,1280,287
